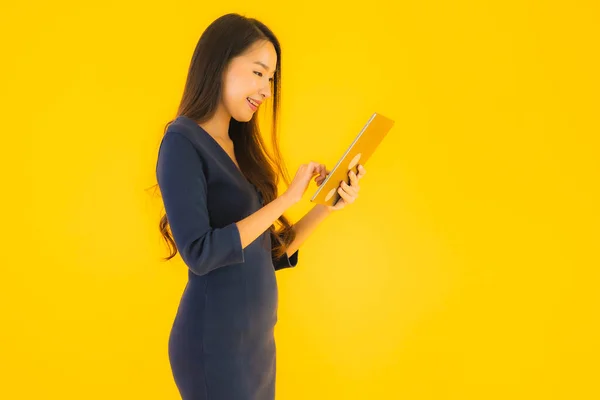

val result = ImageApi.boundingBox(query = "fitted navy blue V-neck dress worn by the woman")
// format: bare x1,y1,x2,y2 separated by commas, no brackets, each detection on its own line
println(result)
156,116,298,400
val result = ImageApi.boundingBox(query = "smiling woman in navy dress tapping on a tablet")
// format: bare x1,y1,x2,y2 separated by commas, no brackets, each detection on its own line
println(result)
156,14,365,400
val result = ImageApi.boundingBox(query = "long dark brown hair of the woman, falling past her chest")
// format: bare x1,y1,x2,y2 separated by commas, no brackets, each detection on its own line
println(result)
154,13,295,261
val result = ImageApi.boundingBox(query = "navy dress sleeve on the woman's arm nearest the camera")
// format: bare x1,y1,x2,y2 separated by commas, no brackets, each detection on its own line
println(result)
156,132,244,275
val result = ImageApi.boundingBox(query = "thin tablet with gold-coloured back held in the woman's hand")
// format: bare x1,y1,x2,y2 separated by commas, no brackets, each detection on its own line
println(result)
310,113,394,206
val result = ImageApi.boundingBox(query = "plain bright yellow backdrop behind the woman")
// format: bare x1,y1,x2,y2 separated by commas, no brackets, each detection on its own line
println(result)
0,0,600,400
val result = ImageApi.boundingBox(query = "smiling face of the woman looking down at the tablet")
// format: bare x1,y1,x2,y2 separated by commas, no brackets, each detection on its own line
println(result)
221,41,277,122
